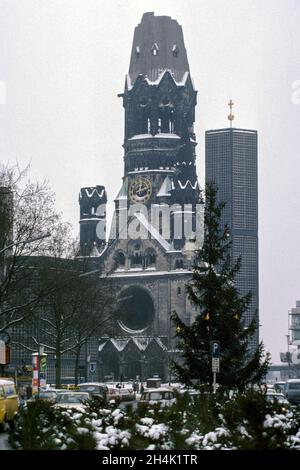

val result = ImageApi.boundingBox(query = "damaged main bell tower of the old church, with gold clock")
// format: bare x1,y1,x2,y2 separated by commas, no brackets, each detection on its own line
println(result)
116,13,200,248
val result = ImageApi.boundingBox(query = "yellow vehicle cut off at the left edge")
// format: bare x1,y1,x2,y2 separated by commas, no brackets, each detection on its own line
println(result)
0,379,19,431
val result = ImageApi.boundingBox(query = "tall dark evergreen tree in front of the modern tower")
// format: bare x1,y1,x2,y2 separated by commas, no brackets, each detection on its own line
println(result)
172,183,270,389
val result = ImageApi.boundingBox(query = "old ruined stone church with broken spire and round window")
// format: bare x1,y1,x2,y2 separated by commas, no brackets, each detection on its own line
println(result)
80,13,201,380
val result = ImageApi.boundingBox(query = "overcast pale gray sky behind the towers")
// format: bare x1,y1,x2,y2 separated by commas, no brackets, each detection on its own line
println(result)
0,0,300,362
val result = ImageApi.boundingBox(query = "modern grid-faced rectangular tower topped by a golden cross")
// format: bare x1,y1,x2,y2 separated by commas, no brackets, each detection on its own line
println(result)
205,126,259,348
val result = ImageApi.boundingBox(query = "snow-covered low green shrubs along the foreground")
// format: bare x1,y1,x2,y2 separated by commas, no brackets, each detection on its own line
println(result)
11,390,300,450
